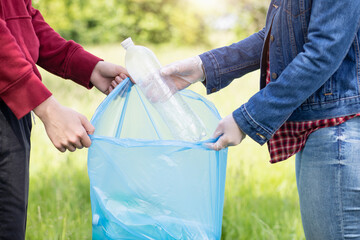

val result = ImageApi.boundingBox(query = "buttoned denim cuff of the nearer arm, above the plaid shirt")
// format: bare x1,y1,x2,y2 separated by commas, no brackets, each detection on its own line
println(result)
233,104,272,145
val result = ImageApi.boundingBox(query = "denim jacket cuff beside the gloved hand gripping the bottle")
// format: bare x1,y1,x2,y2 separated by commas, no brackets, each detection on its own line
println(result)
199,52,221,94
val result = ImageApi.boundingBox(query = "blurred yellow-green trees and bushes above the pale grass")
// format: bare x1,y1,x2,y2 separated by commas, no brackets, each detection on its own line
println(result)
33,0,268,45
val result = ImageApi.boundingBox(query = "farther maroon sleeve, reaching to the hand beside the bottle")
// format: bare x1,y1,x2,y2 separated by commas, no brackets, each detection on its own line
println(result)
29,5,102,88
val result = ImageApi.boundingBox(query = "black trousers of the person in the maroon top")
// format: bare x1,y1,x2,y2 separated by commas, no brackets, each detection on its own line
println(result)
0,100,32,240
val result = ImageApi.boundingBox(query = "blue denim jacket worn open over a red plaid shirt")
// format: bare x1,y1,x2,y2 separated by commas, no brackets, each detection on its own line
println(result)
200,0,360,144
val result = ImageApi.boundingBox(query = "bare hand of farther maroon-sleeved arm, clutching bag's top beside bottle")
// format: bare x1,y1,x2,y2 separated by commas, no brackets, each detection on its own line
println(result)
90,61,129,94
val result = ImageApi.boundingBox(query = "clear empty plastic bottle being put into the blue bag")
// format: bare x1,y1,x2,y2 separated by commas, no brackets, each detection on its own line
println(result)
121,38,206,142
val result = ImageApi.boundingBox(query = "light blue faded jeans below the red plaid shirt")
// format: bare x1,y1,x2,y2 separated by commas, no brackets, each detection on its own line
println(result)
296,117,360,240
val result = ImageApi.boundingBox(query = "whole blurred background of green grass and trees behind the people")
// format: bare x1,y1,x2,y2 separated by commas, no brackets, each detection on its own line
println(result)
26,0,304,240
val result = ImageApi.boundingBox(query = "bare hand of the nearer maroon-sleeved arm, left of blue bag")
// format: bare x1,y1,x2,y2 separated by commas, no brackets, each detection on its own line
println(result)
34,96,95,152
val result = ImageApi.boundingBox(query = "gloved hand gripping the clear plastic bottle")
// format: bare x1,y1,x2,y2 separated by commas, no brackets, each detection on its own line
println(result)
160,56,205,90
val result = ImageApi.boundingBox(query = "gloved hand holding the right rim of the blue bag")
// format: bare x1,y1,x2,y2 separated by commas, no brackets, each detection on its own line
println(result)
207,114,246,151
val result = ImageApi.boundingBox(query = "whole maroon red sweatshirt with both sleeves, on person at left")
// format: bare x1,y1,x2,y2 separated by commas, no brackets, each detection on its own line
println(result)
0,0,101,119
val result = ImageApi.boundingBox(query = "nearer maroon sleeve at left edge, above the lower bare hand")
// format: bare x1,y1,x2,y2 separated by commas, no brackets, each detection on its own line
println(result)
0,19,51,119
